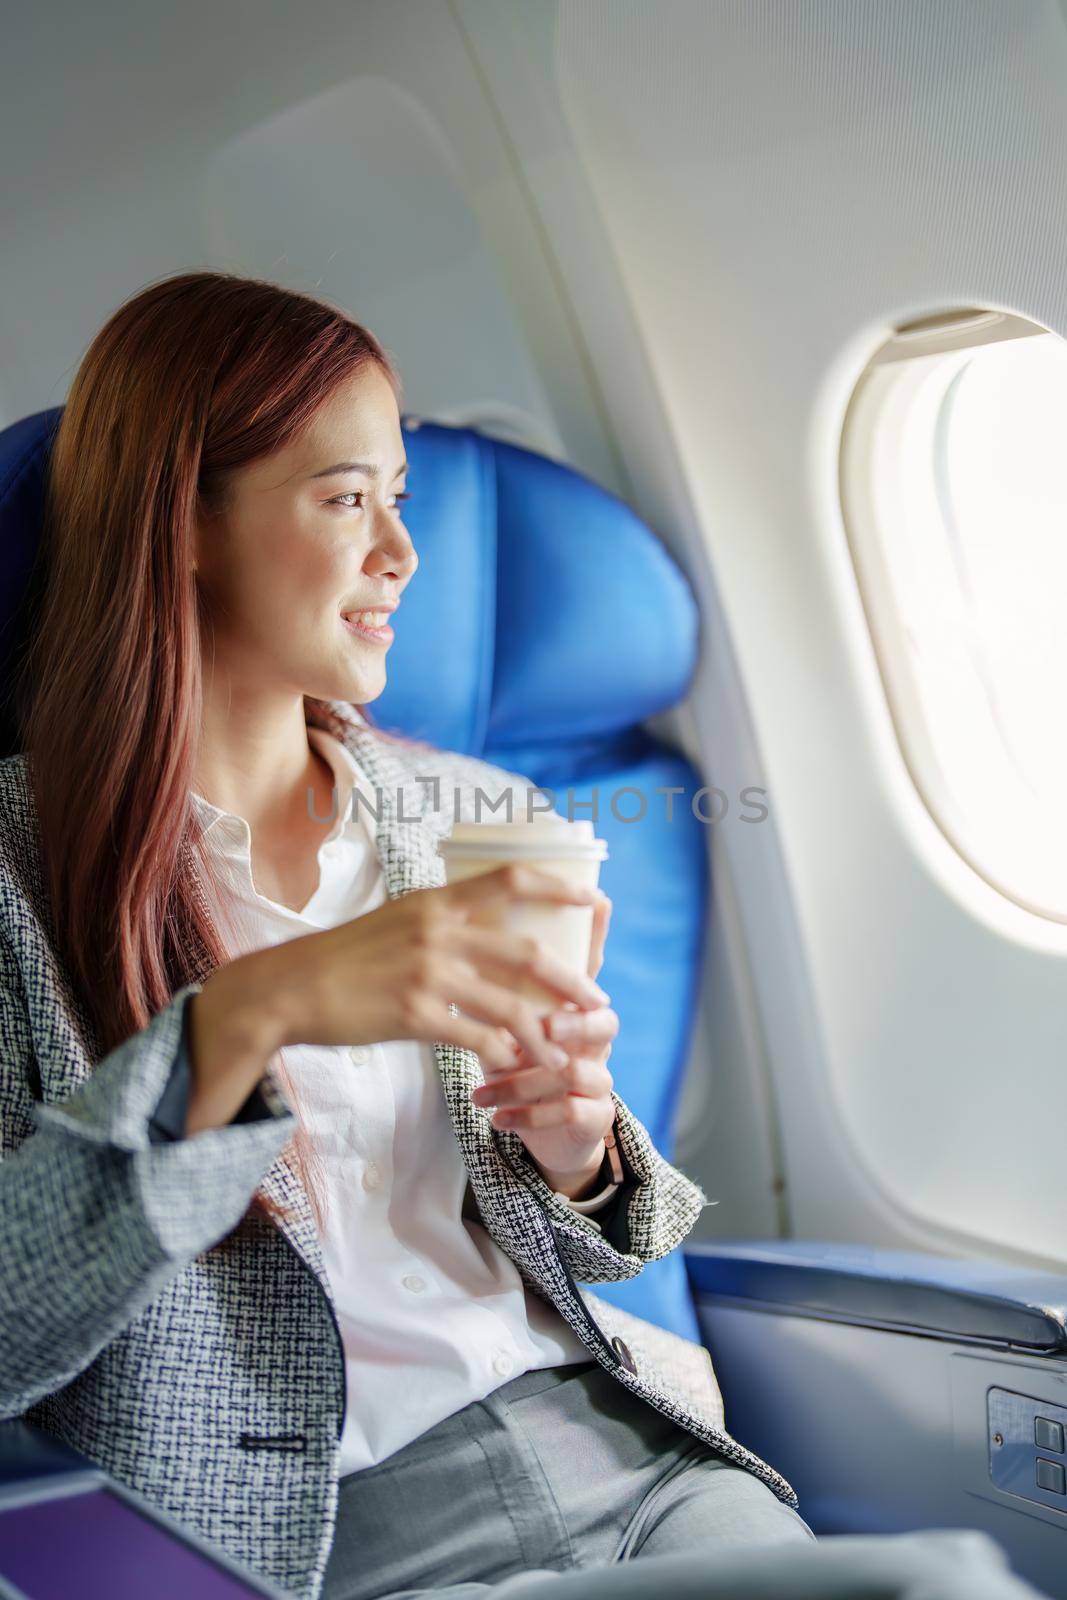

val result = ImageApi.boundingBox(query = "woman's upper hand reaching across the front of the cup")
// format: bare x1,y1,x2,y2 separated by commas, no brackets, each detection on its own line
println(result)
203,862,608,1074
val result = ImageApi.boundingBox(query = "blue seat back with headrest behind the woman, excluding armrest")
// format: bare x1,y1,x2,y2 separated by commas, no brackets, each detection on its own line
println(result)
0,408,707,1339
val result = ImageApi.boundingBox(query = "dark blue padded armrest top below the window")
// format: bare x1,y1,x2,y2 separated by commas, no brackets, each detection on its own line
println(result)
685,1238,1067,1357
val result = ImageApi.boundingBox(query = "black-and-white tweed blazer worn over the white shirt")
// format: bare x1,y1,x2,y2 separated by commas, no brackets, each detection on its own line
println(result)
0,702,797,1600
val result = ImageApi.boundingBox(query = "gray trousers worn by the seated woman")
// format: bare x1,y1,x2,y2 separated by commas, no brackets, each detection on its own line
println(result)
323,1360,1038,1600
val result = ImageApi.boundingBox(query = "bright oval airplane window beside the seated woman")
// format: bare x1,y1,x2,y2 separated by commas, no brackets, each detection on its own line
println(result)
841,310,1067,922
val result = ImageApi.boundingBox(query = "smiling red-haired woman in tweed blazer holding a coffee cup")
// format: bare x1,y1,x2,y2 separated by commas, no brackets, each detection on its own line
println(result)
0,272,814,1600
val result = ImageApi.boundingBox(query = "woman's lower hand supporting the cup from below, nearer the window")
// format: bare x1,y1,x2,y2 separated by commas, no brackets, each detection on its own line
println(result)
470,893,619,1190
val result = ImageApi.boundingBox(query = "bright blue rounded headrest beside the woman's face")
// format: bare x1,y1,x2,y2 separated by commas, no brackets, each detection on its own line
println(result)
374,419,697,755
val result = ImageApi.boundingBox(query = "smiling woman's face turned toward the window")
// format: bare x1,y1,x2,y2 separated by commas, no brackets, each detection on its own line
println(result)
195,363,418,706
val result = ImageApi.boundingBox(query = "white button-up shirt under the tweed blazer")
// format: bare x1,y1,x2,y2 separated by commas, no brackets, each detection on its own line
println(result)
194,726,590,1474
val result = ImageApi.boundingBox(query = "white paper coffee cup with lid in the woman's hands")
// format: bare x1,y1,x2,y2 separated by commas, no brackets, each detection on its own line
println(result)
437,813,608,1014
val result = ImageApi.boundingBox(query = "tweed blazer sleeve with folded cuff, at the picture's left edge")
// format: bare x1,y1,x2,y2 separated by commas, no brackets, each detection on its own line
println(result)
0,939,296,1418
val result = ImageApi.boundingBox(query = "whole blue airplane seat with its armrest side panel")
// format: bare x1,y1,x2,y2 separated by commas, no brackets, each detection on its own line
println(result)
0,410,1067,1600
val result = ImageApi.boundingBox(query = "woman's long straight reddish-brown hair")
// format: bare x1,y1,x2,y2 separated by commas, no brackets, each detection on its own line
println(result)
16,272,403,1214
